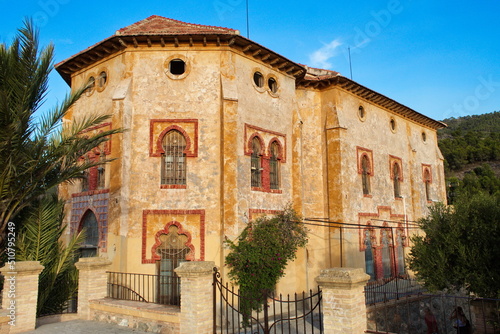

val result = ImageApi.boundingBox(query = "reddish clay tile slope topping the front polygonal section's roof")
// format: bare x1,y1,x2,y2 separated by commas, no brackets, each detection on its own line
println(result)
116,15,239,36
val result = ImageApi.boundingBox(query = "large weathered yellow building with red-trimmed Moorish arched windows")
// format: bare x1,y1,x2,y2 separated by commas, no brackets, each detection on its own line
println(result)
56,16,446,292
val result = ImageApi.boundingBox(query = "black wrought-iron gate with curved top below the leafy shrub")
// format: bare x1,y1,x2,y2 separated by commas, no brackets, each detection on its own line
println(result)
213,268,323,334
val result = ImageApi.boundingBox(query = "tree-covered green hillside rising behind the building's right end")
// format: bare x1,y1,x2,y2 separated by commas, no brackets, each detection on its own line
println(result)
438,111,500,203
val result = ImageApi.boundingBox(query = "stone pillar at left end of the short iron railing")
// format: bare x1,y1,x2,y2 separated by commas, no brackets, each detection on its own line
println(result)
75,257,111,320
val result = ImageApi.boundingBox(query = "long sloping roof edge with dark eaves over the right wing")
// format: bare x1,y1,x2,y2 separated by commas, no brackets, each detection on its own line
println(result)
297,72,446,130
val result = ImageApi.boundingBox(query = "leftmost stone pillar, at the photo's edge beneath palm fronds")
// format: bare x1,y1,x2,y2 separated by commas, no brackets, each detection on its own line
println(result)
0,261,44,334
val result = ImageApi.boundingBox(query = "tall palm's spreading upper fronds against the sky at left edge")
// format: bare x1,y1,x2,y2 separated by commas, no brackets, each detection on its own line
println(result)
0,20,121,245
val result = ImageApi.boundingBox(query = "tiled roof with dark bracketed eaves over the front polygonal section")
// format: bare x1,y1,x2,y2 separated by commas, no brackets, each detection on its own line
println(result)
55,15,306,86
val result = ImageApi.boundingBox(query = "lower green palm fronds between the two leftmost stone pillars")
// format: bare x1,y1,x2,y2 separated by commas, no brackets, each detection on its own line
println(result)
16,195,83,315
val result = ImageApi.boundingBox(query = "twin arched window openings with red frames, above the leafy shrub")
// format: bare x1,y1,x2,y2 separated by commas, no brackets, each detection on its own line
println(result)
250,137,280,189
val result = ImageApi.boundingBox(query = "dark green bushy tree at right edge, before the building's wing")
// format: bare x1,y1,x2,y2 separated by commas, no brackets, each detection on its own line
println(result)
409,193,500,298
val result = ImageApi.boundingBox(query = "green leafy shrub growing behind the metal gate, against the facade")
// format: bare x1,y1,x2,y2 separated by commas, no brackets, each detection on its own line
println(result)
226,207,307,323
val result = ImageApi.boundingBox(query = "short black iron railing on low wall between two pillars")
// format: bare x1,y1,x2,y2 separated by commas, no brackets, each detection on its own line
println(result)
107,272,180,306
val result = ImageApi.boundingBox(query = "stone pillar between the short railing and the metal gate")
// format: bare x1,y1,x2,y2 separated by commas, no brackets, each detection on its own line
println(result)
175,261,215,334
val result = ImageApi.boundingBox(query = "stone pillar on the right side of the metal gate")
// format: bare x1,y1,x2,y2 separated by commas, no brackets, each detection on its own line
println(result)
316,268,370,334
